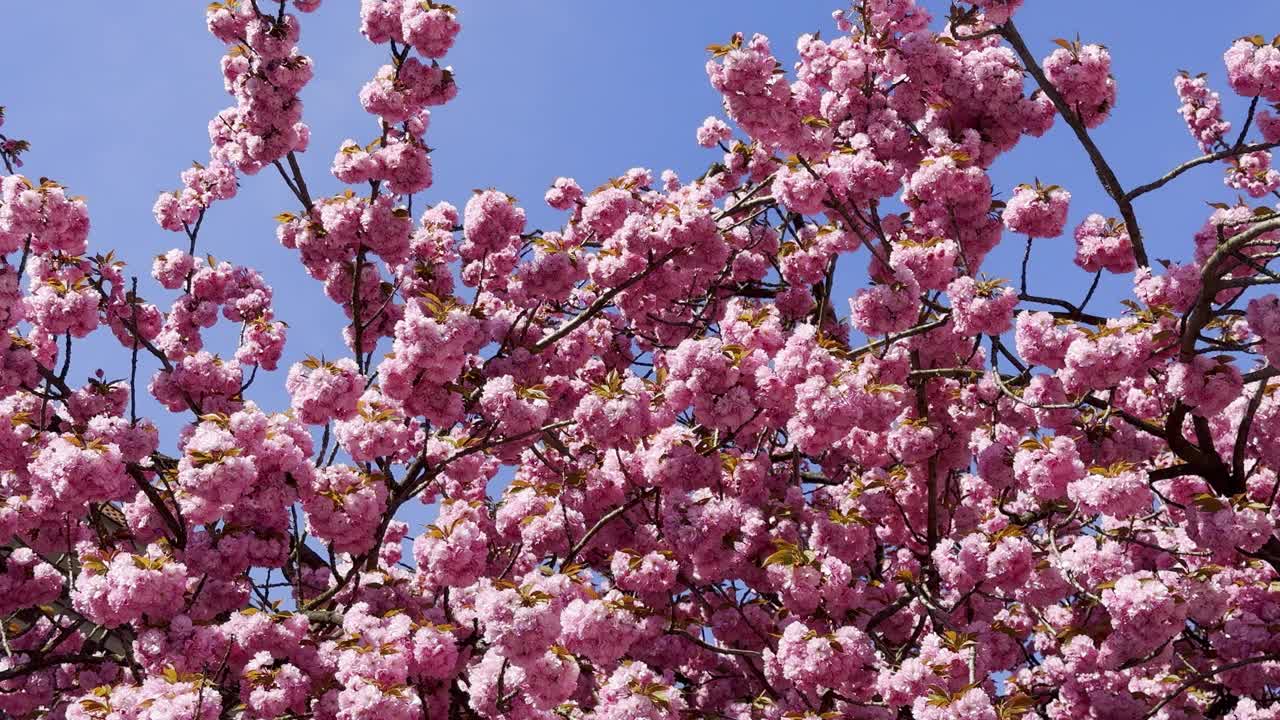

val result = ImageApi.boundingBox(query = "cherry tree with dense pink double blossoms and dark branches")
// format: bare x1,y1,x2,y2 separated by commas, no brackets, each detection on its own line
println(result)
0,0,1280,720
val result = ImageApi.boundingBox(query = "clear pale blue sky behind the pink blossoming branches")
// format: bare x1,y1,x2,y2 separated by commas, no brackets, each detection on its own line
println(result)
0,0,1280,437
